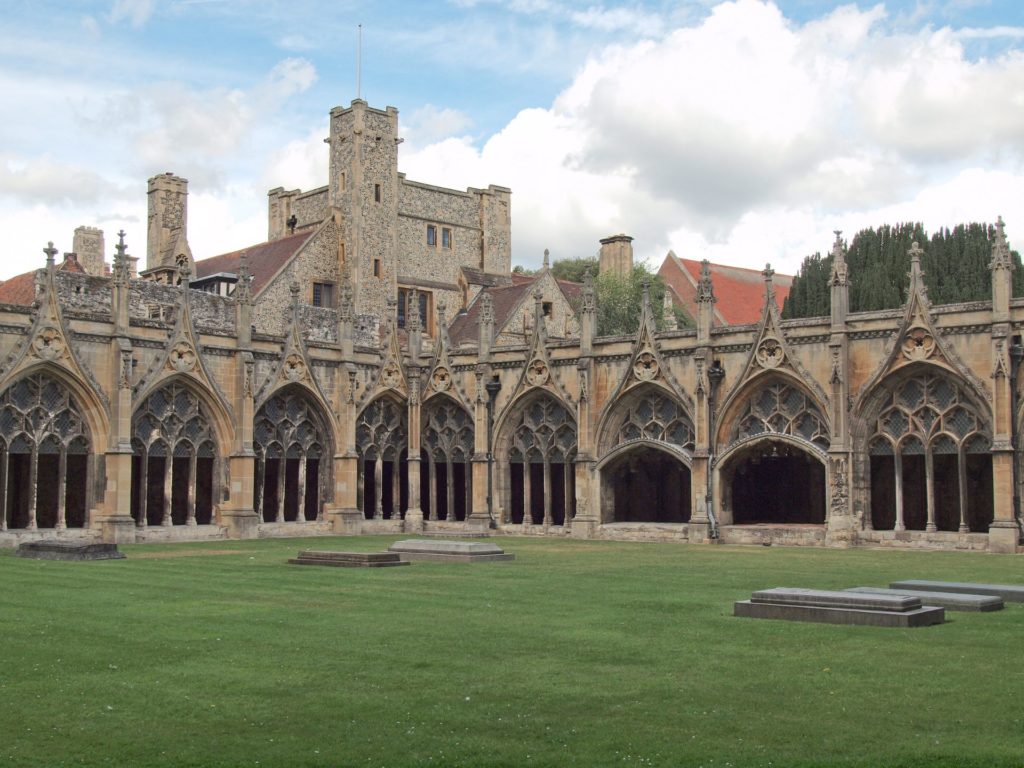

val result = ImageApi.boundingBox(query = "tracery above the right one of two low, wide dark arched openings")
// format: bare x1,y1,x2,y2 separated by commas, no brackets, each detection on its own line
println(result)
730,381,828,450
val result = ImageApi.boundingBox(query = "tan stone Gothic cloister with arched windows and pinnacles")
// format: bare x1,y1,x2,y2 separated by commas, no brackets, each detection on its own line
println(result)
0,225,1024,552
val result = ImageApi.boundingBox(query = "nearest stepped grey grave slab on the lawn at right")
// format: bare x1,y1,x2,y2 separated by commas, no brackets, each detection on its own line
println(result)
733,587,945,627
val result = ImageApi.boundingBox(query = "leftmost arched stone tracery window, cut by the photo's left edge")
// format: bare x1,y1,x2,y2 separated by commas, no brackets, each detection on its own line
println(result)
0,373,90,530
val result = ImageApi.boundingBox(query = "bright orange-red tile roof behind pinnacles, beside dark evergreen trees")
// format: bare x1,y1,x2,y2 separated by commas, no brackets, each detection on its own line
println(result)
657,251,793,326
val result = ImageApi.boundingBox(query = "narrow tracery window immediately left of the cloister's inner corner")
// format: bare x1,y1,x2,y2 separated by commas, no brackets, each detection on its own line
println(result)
355,397,408,520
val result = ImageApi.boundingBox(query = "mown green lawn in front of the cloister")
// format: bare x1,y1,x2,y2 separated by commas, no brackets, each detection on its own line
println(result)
0,537,1024,768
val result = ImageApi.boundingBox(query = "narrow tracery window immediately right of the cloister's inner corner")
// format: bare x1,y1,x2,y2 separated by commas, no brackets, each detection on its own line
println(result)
421,397,473,521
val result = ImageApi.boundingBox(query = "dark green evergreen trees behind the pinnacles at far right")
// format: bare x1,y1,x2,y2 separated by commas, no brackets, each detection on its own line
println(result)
782,223,1024,317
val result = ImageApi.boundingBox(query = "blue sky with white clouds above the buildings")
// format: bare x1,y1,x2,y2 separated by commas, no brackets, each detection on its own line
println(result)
0,0,1024,279
